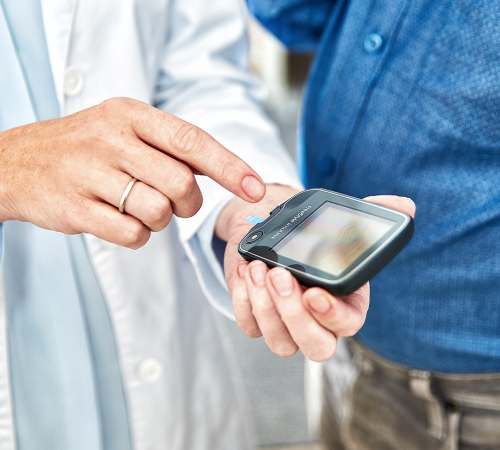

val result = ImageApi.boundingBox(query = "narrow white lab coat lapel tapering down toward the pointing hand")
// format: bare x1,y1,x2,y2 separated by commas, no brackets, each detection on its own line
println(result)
41,0,77,107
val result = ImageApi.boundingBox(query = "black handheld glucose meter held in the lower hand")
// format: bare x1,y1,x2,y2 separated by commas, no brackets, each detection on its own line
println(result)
238,189,413,295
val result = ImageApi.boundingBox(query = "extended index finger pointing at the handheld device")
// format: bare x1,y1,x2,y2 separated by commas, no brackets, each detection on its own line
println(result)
133,104,266,202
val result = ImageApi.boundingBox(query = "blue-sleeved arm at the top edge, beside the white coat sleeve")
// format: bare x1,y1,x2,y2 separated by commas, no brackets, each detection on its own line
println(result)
247,0,335,52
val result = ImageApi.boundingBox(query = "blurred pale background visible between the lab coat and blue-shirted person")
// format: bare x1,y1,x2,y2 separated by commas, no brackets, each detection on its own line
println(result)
218,14,321,450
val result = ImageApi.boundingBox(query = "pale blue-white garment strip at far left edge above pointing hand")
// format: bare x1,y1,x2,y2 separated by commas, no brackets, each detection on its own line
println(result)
0,1,36,131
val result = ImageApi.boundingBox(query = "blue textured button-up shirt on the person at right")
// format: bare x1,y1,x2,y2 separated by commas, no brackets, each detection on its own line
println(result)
249,0,500,372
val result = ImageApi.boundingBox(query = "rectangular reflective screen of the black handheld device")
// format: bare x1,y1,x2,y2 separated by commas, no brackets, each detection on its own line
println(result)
272,202,395,277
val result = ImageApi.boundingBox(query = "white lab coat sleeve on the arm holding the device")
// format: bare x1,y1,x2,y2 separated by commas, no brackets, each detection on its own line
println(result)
154,0,301,315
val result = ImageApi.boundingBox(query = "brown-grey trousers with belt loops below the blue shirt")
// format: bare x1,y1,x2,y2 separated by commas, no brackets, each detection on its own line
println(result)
320,339,500,450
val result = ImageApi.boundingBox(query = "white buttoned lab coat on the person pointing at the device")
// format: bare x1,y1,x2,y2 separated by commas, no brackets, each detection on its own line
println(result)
0,0,300,450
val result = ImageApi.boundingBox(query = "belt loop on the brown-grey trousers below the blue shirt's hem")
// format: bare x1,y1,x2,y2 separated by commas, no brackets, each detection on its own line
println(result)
408,370,447,440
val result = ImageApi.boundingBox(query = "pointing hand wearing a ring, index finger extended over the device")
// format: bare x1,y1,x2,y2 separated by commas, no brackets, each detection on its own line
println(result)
0,98,265,249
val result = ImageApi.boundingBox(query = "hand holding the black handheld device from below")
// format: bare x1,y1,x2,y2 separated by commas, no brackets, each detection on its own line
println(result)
215,185,415,362
